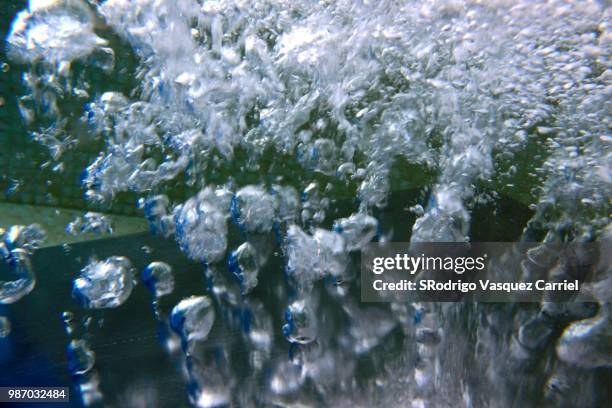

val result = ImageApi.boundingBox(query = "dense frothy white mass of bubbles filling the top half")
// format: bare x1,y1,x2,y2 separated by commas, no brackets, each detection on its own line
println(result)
8,0,609,240
